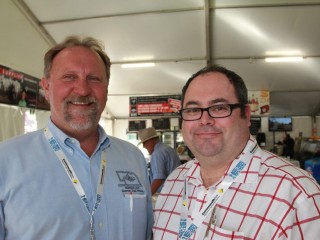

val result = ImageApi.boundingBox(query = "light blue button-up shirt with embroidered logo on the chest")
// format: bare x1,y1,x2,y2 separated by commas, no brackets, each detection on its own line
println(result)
0,120,153,240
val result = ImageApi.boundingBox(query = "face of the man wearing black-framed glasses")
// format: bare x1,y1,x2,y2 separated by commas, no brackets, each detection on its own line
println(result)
182,72,250,161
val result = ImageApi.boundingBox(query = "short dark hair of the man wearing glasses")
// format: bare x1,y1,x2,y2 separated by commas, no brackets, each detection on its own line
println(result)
181,64,248,117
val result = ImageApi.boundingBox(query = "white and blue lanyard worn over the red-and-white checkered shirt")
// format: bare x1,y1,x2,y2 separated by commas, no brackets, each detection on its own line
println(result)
179,143,258,240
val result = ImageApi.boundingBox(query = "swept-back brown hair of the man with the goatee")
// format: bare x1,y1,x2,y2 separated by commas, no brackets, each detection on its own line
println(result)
44,36,111,81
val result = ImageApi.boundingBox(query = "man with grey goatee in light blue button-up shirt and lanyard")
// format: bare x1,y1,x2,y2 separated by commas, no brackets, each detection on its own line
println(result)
0,36,153,240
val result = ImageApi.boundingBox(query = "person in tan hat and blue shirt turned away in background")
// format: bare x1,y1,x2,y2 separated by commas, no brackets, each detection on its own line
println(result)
138,127,180,195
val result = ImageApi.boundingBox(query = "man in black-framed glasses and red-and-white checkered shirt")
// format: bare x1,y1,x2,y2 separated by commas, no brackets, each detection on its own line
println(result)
153,65,320,240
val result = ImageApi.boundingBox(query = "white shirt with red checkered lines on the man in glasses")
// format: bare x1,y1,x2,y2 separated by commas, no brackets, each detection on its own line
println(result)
153,136,320,240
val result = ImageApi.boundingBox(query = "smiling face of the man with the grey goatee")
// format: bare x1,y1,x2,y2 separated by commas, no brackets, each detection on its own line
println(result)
41,46,108,136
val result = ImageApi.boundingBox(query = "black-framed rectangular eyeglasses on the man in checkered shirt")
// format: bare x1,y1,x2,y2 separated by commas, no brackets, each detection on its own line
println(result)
180,103,244,121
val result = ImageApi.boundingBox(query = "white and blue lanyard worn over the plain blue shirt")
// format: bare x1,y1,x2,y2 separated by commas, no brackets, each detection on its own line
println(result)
44,128,107,240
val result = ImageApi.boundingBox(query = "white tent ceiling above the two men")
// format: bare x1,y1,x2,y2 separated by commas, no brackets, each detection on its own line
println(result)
12,0,320,118
